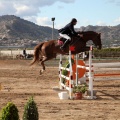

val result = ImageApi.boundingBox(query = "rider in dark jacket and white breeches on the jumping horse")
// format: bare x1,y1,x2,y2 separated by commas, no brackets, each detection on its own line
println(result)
58,18,78,50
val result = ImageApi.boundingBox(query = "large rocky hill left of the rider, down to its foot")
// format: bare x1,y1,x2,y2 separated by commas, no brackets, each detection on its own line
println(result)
0,15,58,45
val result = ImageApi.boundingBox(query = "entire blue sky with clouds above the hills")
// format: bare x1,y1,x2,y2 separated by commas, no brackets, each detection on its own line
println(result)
0,0,120,29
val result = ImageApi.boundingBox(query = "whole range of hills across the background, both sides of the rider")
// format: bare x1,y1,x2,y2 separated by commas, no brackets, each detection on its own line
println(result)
0,15,120,47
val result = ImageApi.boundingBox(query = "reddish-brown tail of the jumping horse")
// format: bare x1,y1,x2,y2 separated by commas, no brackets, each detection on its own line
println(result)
30,42,44,65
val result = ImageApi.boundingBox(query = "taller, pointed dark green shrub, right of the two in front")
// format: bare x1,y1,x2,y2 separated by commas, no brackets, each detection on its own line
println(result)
23,97,39,120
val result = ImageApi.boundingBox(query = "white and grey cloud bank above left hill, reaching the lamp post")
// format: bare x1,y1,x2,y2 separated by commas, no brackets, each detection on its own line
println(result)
0,0,76,26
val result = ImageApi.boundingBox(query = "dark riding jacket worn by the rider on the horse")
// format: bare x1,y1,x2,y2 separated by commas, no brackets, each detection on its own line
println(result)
58,23,78,36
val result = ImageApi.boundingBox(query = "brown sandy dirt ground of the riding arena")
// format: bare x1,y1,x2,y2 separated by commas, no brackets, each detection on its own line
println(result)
0,60,120,120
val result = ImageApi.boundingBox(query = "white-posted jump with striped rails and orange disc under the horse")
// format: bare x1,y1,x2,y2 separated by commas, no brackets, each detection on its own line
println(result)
59,46,95,99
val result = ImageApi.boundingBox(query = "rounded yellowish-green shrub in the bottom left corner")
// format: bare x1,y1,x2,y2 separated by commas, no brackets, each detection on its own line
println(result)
1,102,19,120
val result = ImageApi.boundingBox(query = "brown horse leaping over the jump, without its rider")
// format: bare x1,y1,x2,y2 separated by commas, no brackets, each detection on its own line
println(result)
31,31,102,74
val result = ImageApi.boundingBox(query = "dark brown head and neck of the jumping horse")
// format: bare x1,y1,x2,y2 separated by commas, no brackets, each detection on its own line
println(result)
79,31,102,49
